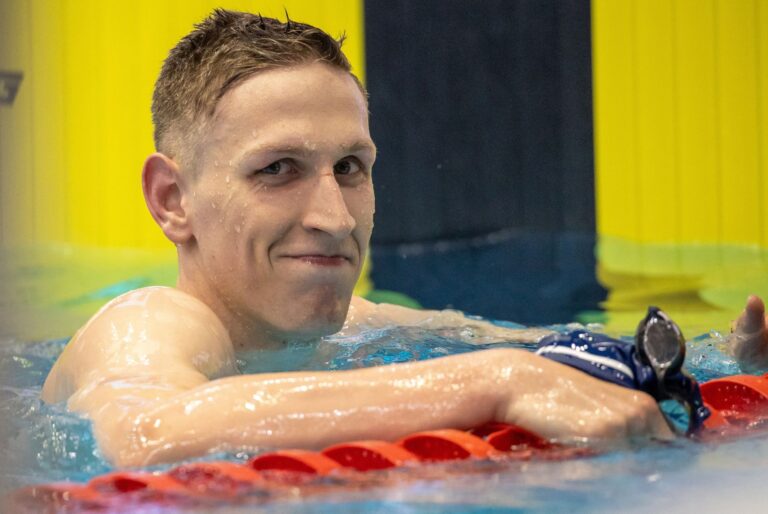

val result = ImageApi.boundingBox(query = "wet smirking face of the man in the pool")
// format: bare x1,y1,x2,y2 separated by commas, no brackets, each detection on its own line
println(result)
182,63,376,342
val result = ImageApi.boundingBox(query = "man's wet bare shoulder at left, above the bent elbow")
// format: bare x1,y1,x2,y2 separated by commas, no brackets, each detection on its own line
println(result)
42,287,235,402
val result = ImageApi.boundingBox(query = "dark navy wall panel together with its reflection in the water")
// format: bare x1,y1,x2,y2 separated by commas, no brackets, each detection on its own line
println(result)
365,0,605,323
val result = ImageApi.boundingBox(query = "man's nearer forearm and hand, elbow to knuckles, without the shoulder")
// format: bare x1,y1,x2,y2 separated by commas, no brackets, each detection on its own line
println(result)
74,349,670,466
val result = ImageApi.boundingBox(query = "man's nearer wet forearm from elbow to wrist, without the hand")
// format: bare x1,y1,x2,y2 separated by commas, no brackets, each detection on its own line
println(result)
94,350,530,465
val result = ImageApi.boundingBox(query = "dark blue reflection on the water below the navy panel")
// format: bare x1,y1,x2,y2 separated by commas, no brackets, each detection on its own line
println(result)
371,231,606,324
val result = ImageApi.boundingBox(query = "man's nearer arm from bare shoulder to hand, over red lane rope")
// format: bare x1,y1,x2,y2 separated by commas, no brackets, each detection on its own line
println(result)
43,288,669,466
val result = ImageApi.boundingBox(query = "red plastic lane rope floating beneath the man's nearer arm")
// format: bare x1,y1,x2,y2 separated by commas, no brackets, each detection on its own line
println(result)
13,374,768,511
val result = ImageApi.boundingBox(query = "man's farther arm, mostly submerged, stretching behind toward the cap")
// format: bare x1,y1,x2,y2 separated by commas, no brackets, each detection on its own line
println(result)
347,297,553,343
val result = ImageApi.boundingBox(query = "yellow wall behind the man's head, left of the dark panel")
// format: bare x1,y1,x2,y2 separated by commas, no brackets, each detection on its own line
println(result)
0,0,364,248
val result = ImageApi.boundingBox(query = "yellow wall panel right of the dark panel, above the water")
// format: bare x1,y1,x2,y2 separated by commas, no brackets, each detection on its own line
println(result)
592,0,768,247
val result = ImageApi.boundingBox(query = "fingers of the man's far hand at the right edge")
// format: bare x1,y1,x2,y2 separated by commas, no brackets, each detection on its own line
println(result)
728,295,768,371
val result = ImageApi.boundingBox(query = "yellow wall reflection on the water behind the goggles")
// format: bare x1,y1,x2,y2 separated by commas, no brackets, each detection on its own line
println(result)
596,237,768,337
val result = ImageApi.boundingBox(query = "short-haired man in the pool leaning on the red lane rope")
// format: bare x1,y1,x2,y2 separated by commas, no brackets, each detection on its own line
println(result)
42,11,768,466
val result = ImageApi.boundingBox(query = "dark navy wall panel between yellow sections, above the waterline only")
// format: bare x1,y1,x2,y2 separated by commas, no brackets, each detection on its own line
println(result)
365,0,595,243
